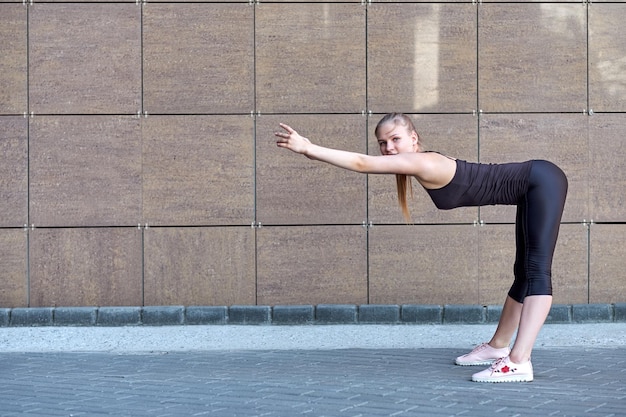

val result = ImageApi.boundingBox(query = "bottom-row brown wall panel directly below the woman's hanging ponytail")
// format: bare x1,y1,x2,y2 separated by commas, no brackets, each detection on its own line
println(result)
369,225,479,304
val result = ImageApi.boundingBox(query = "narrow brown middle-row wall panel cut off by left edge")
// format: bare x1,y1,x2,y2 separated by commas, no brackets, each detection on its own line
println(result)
0,116,28,227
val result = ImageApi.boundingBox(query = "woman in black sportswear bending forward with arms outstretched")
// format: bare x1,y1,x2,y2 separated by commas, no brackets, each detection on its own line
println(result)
276,113,567,382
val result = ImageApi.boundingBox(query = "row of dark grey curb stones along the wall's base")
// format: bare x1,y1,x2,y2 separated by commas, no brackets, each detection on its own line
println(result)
0,303,626,327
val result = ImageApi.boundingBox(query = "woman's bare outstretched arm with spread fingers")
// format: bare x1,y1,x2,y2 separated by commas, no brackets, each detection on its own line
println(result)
275,123,424,176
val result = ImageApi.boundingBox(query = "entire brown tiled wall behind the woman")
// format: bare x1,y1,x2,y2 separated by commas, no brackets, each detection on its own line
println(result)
0,0,626,307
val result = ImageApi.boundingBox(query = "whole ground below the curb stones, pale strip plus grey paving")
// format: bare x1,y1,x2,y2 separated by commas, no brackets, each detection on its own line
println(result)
0,323,626,417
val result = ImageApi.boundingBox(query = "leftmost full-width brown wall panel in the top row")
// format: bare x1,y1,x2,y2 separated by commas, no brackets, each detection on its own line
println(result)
29,3,141,114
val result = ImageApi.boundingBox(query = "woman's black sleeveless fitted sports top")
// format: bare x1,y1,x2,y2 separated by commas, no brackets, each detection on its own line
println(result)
426,159,532,210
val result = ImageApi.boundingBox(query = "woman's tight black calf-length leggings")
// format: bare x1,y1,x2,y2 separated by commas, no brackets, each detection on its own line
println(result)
509,161,567,303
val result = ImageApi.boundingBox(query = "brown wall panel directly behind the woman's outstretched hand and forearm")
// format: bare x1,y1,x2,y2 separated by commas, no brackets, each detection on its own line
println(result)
256,115,367,224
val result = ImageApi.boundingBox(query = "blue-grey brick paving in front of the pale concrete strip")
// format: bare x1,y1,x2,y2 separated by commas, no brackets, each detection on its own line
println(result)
0,348,626,417
